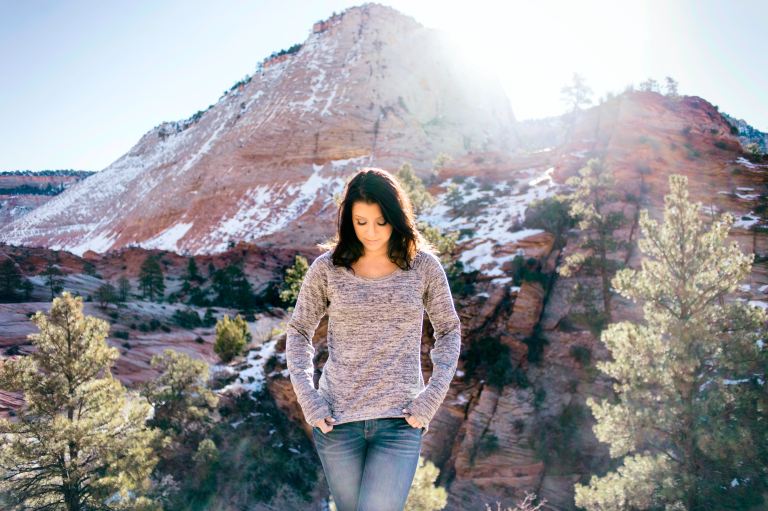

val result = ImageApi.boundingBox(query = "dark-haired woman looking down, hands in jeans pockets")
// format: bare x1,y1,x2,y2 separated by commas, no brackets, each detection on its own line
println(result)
286,168,461,511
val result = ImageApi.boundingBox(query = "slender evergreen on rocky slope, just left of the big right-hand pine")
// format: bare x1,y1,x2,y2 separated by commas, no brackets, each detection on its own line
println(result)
558,158,625,321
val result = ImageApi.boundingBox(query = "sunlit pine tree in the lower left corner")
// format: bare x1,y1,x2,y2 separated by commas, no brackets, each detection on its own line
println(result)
0,292,157,511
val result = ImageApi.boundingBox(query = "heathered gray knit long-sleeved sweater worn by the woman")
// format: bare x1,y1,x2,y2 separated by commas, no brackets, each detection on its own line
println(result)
285,250,461,433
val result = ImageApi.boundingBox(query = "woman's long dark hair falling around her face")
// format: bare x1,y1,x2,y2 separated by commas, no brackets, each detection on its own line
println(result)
320,167,434,270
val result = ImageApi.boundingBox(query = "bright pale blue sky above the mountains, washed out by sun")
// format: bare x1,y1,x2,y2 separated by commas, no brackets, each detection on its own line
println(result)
0,0,768,171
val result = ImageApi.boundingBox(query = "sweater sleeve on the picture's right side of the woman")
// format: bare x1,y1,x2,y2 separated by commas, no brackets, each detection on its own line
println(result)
408,254,461,424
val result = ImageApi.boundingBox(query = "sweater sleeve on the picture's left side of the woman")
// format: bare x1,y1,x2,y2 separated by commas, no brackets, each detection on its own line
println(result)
285,257,331,426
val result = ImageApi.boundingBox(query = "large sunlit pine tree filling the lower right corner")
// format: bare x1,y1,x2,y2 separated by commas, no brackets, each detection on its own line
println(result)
575,175,768,511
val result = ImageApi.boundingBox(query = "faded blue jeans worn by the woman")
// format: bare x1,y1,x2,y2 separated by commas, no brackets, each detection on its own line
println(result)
312,417,424,511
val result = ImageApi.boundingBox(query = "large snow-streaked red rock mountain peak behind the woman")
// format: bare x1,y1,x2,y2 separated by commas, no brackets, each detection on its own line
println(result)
0,4,517,255
